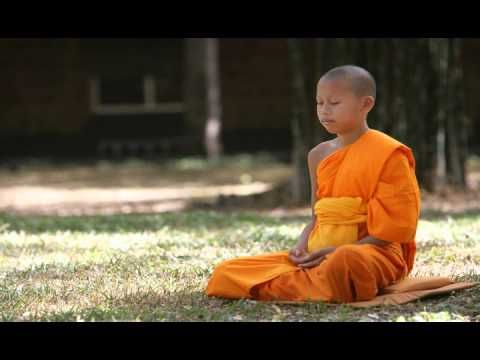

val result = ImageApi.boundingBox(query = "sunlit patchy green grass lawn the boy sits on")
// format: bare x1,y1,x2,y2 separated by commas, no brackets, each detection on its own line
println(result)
0,210,480,321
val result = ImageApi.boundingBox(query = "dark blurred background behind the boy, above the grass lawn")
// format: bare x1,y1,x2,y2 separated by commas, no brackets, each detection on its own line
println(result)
0,38,480,215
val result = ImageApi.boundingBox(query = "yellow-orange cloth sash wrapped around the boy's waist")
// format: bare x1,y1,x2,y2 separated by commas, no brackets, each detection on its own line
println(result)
308,197,367,252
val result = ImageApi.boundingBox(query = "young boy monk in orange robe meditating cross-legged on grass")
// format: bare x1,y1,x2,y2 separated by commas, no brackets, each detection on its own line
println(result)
206,65,420,303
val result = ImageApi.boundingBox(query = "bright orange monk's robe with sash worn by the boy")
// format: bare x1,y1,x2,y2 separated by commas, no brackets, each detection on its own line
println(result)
206,129,420,303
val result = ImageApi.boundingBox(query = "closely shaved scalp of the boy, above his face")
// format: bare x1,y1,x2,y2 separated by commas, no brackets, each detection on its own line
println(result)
319,65,377,99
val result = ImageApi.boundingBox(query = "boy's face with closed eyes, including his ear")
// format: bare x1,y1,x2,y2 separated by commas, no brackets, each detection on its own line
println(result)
316,79,373,134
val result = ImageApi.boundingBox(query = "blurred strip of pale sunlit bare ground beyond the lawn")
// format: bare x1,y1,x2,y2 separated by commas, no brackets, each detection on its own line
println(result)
0,155,292,216
